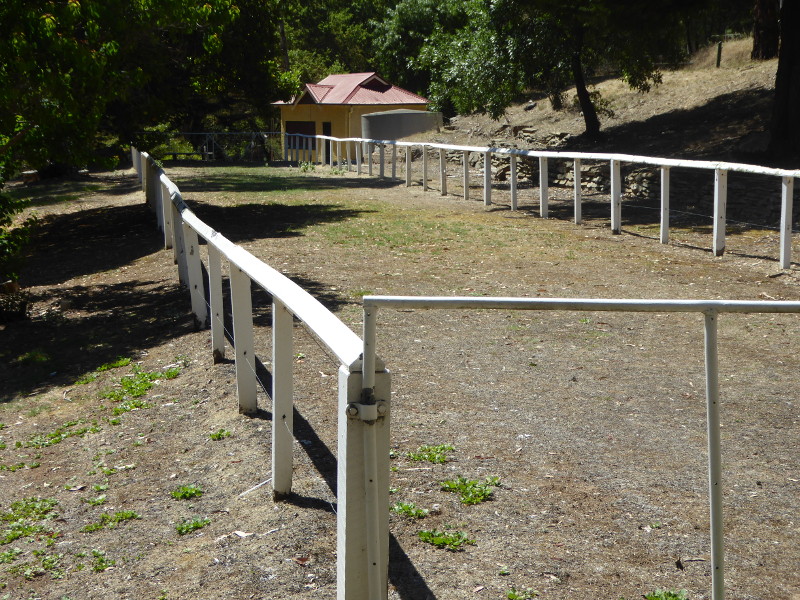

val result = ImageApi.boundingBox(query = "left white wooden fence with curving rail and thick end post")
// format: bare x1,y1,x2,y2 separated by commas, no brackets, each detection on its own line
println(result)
131,148,390,600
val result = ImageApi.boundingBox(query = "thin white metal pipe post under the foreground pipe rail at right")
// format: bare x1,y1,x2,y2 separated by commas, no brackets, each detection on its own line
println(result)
705,310,725,600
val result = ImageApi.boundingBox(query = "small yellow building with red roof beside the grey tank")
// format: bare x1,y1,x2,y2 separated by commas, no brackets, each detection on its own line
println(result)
274,72,428,161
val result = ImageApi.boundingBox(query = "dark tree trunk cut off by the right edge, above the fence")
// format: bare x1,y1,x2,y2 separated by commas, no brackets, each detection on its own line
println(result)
769,0,800,158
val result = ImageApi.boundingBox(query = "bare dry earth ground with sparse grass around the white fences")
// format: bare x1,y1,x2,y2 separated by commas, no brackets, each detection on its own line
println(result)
0,44,800,600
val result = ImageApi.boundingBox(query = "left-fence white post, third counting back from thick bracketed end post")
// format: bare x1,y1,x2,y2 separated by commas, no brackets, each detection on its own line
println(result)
230,263,258,414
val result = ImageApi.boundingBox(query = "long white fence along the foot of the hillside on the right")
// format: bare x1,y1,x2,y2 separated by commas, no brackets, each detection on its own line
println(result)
283,134,800,269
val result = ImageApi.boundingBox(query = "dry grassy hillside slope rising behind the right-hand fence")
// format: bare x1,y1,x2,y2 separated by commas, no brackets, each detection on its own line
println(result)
439,39,777,163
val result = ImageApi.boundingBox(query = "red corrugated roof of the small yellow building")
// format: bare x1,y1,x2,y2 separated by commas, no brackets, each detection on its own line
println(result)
275,72,428,104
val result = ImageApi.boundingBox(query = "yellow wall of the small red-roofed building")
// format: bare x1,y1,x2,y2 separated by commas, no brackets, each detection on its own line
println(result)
280,104,428,162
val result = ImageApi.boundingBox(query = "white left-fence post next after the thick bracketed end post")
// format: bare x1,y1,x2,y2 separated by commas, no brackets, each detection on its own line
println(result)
272,298,294,500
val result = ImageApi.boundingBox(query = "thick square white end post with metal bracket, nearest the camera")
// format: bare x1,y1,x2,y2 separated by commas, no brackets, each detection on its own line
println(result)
336,366,391,600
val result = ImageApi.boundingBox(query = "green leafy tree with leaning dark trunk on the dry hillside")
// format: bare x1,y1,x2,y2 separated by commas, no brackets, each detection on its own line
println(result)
394,0,697,137
